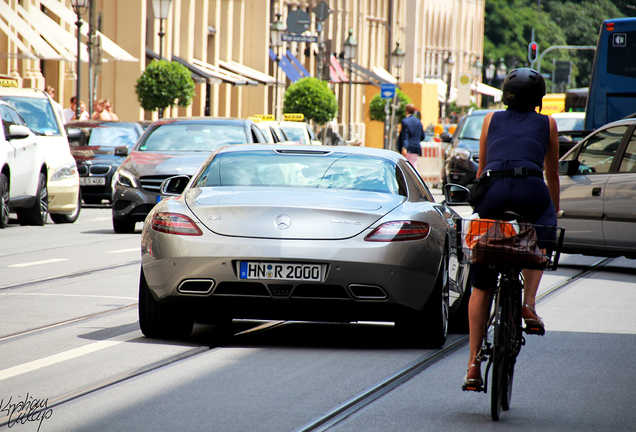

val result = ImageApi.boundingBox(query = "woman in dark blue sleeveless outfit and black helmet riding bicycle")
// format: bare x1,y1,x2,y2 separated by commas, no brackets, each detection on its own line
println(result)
463,68,559,390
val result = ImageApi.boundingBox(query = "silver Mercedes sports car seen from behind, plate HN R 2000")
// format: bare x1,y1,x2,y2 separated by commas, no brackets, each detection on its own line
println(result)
139,144,468,347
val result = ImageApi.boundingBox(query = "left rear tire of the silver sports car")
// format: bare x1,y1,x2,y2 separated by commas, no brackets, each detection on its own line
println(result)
139,270,194,339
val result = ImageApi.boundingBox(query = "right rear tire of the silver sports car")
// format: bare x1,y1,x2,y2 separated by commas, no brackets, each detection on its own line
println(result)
396,246,449,349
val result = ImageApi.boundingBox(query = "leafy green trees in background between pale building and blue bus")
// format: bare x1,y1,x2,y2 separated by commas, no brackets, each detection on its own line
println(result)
483,0,634,91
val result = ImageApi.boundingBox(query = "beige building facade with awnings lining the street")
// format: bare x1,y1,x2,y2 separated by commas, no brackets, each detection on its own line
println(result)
0,0,485,146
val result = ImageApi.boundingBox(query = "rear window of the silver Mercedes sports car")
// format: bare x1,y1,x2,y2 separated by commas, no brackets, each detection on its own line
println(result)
194,150,400,195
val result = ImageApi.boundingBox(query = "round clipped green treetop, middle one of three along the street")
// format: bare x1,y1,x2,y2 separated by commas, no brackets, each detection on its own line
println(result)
283,77,338,125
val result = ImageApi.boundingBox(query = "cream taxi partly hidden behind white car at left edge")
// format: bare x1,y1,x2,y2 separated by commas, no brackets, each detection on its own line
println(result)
0,86,82,223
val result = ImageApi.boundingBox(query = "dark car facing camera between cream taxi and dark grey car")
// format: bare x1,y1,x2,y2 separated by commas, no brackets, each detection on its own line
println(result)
65,120,143,204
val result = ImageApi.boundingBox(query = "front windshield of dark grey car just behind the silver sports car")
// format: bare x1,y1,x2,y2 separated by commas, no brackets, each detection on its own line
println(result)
138,123,249,153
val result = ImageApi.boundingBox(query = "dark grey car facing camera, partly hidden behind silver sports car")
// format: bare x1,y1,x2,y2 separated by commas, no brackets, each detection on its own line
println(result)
112,117,266,233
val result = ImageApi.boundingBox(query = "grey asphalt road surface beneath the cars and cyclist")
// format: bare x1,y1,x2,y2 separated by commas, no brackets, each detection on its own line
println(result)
0,200,636,432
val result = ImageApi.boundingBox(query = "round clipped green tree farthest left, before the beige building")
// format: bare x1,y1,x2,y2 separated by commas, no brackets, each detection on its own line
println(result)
135,60,195,118
